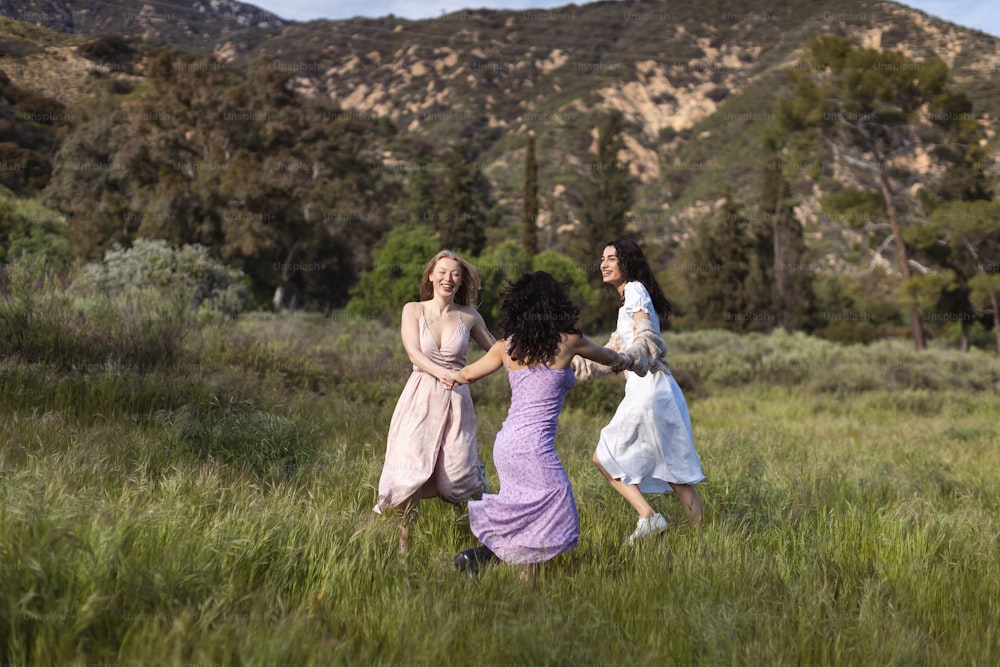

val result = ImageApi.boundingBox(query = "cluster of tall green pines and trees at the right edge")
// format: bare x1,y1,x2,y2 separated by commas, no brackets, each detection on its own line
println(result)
686,36,1000,354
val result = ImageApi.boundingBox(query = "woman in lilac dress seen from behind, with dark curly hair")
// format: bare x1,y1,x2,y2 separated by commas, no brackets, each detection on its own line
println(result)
442,271,630,575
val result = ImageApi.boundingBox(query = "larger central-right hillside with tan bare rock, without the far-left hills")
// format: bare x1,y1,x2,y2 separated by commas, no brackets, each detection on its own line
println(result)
229,0,1000,240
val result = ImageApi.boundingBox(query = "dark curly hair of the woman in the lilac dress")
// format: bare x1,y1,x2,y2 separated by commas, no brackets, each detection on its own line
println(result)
497,271,580,366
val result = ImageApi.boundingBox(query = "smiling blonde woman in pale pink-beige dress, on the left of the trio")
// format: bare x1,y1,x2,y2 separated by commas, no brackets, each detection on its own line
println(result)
374,250,496,552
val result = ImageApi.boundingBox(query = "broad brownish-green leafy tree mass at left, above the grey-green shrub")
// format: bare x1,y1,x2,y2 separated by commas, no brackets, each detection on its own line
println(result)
38,51,402,304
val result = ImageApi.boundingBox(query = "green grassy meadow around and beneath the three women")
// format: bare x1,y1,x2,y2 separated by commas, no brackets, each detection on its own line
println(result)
0,290,1000,666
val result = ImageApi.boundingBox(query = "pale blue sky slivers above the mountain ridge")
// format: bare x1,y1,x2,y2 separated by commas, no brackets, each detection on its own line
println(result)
243,0,1000,37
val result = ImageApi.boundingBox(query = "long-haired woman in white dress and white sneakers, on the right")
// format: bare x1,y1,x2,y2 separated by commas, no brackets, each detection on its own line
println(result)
593,238,705,544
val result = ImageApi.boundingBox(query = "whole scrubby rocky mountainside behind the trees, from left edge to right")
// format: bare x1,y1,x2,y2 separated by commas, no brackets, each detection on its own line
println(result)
0,0,1000,266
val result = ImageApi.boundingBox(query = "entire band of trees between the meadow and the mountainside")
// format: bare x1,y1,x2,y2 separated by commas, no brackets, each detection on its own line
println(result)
0,29,1000,349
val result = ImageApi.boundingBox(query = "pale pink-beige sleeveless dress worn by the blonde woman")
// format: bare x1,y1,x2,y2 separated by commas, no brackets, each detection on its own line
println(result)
374,315,488,513
